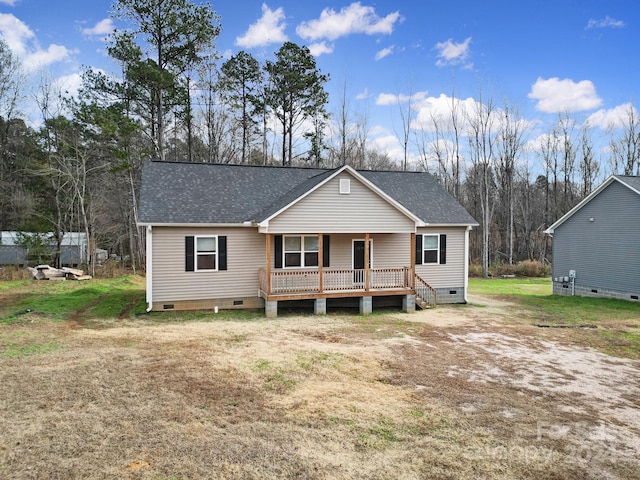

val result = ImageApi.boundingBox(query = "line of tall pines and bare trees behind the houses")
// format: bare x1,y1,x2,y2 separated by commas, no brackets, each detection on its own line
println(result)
0,0,640,275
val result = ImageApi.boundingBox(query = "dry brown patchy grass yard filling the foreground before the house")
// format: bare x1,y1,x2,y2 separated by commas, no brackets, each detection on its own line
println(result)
0,296,640,480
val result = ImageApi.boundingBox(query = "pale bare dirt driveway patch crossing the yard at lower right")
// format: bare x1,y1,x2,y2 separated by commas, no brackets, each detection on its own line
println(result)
397,296,640,478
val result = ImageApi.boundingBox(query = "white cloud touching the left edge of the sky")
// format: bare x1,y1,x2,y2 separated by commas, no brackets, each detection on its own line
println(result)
0,13,77,72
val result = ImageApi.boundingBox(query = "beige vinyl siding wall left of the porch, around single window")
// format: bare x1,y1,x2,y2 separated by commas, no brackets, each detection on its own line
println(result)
152,227,265,302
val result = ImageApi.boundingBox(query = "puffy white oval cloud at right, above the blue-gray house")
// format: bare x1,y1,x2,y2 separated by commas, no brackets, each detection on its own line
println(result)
528,77,602,113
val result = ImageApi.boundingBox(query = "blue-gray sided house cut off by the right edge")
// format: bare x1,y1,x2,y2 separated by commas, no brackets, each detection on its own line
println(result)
545,175,640,301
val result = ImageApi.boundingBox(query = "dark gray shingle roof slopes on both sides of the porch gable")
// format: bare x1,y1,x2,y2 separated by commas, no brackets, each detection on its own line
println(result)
138,161,477,225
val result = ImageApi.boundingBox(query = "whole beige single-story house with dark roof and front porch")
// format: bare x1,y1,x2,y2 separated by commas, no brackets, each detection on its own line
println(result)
138,161,477,316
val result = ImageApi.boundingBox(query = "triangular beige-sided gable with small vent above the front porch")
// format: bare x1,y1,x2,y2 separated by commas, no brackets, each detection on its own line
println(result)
269,172,415,233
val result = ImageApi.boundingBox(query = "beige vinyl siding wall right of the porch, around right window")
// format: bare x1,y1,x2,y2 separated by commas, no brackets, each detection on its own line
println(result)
416,227,466,291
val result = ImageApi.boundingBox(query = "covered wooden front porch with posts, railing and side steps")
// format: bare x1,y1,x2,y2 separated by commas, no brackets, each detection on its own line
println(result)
259,233,436,317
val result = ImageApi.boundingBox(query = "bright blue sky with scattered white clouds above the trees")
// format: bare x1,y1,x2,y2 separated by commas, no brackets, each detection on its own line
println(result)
0,0,640,169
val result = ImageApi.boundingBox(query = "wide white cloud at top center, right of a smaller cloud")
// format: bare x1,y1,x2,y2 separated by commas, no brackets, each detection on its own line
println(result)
296,2,402,40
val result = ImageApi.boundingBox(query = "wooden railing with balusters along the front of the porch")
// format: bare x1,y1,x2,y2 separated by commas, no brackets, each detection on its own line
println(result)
260,267,413,295
